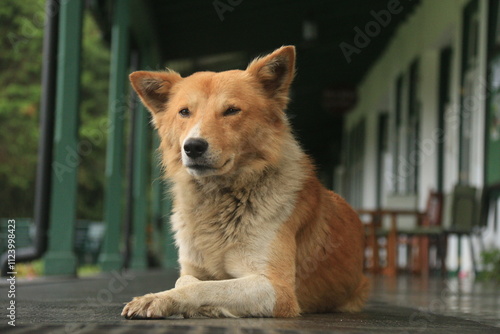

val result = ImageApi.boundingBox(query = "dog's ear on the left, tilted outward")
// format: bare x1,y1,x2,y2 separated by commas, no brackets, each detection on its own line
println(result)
129,71,182,115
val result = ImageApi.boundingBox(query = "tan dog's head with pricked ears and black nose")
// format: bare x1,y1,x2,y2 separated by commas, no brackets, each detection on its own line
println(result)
130,46,295,178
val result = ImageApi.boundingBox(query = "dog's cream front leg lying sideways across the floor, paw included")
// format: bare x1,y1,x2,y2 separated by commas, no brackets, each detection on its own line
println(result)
122,275,282,318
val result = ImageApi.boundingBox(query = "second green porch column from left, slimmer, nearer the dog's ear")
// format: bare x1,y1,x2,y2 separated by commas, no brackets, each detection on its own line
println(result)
99,0,130,271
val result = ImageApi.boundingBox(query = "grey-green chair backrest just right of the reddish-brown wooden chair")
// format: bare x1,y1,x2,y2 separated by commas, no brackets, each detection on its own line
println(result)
451,184,478,233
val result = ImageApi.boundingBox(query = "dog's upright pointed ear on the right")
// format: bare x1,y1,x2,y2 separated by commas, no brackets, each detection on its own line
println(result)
246,46,295,98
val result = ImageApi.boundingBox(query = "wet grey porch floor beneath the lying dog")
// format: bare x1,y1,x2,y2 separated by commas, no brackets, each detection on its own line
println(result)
0,271,500,334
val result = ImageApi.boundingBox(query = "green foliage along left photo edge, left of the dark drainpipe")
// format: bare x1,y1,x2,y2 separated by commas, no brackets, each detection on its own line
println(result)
0,0,44,217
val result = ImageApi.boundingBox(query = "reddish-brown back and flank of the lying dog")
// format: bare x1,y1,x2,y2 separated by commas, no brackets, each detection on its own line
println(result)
254,157,370,313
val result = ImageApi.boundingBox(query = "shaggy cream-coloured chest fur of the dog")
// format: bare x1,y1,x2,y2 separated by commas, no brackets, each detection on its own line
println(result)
172,149,303,279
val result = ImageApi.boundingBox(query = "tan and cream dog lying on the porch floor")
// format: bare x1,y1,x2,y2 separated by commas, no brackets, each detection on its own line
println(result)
121,46,370,318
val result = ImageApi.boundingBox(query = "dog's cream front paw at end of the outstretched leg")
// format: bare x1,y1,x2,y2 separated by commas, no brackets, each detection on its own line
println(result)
121,293,179,319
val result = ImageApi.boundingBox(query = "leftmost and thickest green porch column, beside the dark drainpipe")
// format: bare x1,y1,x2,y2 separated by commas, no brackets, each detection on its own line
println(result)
44,0,83,275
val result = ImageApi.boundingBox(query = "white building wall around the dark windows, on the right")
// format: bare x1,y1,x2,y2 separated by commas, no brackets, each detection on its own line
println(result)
345,0,490,272
